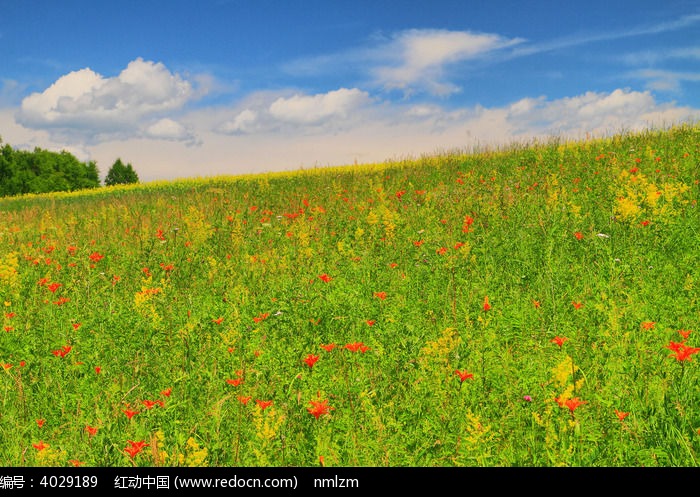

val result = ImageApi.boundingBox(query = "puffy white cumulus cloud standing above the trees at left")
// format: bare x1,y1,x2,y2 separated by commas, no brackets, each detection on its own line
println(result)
16,58,194,141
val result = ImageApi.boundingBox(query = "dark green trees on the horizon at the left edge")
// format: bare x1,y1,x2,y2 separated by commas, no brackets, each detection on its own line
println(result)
0,138,139,197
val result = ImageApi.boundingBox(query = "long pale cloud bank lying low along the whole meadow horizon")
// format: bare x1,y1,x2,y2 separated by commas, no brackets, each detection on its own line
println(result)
0,89,700,181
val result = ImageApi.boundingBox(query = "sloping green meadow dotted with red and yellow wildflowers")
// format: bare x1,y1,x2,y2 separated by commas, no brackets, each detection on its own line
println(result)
0,125,700,467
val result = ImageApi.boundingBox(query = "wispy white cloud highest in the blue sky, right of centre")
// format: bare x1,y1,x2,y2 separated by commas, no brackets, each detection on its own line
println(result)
373,29,522,96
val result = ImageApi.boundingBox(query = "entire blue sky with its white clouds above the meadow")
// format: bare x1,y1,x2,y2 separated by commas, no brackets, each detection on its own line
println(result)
0,0,700,181
